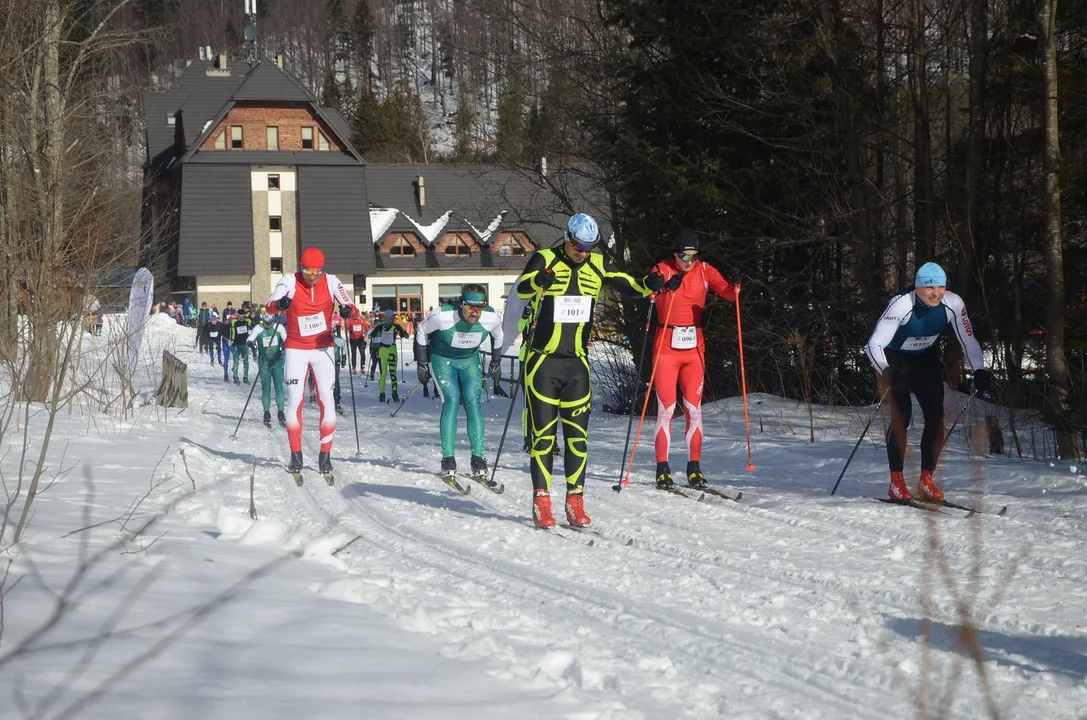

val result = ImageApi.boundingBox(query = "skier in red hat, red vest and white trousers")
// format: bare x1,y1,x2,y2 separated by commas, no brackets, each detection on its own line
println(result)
265,248,355,473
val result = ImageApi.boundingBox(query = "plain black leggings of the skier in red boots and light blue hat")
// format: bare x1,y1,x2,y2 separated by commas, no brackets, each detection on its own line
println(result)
887,347,944,472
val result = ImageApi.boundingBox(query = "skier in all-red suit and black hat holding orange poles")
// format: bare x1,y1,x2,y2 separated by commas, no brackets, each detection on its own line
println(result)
647,228,740,488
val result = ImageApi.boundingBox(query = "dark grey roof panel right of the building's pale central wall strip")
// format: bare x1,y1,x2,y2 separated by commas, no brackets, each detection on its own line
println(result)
298,165,376,277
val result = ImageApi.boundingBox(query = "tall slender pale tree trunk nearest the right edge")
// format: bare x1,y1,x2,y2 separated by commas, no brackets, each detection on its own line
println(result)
1038,0,1079,458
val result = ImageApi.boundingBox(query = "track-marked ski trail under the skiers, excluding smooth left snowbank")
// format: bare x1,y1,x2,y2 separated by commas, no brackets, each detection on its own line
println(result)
8,319,1087,720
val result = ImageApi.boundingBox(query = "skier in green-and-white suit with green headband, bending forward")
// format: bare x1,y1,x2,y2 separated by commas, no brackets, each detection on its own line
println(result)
414,284,502,489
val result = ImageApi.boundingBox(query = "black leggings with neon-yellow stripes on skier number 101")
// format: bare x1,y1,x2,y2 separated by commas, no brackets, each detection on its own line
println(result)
525,352,592,495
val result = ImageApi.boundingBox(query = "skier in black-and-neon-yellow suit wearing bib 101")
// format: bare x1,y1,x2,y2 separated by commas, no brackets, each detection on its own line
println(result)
516,213,659,527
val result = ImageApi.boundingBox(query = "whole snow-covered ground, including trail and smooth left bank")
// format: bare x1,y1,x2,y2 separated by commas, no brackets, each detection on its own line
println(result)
0,319,1087,720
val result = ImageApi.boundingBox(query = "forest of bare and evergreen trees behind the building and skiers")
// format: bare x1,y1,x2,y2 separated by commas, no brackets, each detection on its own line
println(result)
0,0,1087,457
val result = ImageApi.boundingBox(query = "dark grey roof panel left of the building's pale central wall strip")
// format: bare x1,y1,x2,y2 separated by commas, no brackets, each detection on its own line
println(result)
177,164,254,276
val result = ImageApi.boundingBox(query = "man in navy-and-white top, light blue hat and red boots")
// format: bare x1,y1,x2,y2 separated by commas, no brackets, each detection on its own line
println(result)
867,262,992,500
